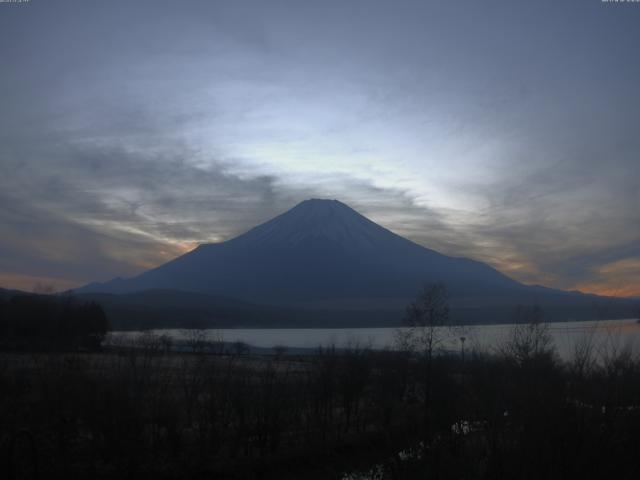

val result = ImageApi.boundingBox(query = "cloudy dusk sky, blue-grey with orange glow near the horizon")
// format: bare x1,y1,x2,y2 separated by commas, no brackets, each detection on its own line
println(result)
0,0,640,296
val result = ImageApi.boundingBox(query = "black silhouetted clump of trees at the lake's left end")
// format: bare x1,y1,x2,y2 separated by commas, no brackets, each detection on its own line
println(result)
0,294,109,351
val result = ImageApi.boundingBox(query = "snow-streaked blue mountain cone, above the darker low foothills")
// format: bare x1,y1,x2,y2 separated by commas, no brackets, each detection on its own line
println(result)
80,200,525,306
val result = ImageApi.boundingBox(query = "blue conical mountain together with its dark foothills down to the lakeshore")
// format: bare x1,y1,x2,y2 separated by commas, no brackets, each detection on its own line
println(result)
72,200,631,326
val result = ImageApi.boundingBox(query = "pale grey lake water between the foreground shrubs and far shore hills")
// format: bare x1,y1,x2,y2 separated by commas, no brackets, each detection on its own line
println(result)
109,319,640,359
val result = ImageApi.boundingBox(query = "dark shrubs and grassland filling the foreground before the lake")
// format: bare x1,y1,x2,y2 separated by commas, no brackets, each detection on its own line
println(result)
0,323,640,479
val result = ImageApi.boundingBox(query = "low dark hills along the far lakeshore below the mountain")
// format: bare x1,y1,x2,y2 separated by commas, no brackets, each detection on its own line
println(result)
0,289,635,330
